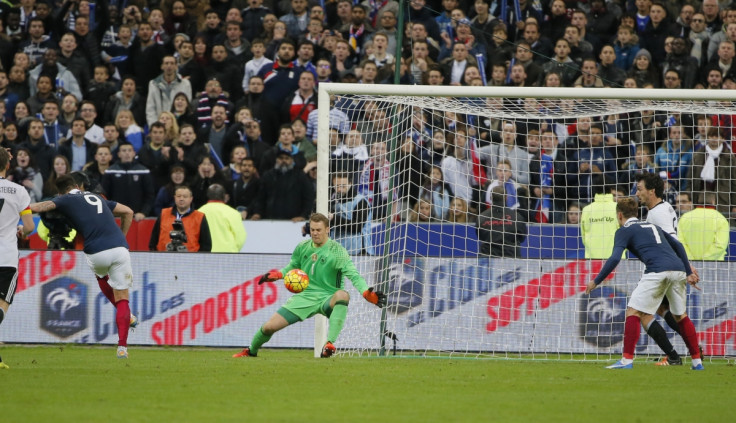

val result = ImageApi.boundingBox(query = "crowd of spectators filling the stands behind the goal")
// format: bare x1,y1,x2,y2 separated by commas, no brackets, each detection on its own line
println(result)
0,0,736,250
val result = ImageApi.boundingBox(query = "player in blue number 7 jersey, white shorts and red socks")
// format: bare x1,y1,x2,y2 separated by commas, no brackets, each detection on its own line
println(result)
585,198,703,370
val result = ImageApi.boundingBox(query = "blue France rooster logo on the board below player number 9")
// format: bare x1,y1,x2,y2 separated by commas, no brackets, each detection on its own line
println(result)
41,277,87,338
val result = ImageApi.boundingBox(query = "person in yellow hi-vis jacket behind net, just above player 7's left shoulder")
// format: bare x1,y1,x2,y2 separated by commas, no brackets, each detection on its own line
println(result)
580,178,618,259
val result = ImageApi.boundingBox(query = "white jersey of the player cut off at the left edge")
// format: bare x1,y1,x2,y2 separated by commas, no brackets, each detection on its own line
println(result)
0,177,31,268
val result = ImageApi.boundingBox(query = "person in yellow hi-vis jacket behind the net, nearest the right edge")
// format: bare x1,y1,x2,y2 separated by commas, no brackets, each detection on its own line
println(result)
677,192,729,261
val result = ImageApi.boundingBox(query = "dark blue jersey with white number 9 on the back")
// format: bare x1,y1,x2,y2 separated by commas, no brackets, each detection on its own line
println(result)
51,191,128,254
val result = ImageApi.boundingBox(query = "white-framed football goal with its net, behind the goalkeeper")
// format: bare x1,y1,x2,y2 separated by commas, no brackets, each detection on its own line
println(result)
315,84,736,359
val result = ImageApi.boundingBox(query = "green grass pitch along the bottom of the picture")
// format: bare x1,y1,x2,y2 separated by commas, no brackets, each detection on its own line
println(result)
0,345,736,423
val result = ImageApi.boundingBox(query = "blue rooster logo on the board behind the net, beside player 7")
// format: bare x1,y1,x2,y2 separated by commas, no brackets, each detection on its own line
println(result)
578,286,626,348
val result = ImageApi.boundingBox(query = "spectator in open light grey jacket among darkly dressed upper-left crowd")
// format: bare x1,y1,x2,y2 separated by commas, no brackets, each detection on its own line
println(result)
146,56,192,126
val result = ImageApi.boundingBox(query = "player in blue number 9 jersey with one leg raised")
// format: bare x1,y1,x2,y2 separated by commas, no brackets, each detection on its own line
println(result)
31,175,137,358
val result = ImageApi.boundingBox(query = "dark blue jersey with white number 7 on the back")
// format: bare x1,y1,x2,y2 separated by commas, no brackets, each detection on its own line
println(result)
595,219,692,284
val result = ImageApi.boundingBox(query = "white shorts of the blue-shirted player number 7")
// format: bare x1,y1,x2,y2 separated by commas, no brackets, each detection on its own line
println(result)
629,271,687,316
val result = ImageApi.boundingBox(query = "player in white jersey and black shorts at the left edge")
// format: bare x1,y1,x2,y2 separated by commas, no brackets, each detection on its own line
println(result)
0,147,35,369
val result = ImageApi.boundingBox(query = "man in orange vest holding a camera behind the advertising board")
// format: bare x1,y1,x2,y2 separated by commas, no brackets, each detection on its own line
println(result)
148,185,212,252
